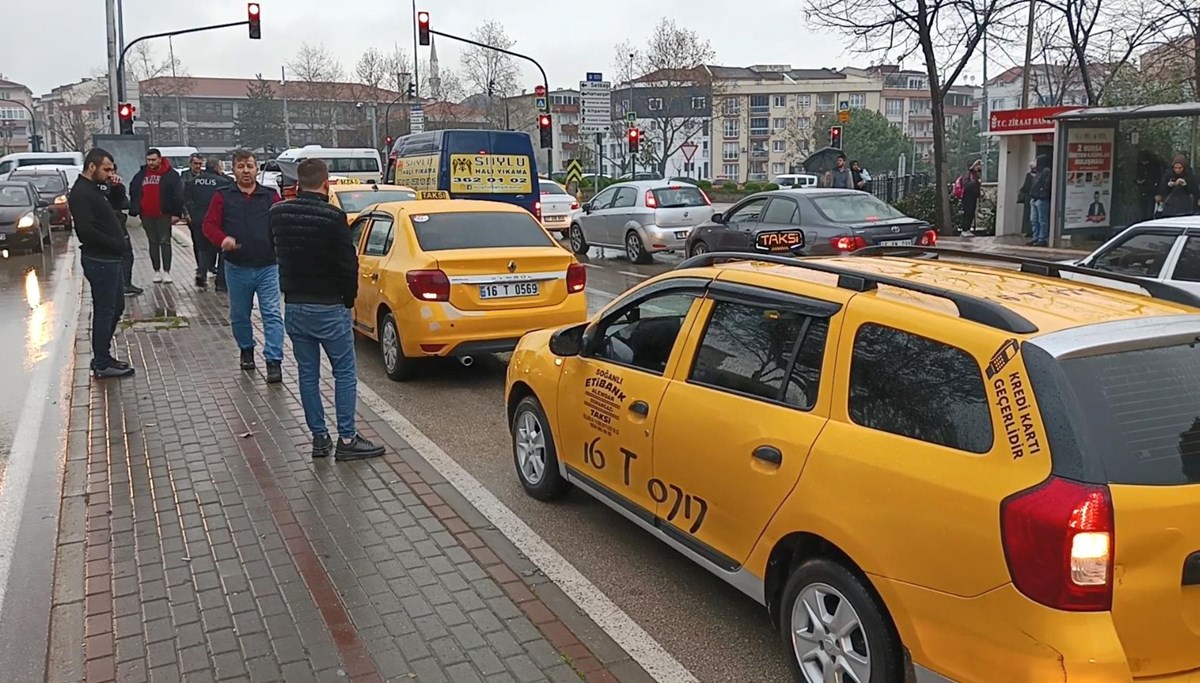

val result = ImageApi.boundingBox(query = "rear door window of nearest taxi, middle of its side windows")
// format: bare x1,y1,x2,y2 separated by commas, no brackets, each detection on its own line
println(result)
689,301,829,409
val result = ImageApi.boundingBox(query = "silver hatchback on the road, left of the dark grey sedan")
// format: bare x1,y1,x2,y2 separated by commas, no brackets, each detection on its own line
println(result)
569,180,713,263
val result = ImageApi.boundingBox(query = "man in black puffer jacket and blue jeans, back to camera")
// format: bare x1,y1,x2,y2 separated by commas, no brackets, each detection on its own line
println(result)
270,158,383,460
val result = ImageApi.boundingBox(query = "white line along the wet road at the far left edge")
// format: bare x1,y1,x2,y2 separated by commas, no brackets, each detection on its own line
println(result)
0,256,83,615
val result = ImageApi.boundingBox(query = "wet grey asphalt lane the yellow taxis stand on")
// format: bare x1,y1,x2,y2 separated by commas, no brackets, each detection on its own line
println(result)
358,241,790,683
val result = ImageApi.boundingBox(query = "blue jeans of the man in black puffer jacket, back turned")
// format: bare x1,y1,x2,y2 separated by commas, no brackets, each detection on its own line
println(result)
286,304,358,439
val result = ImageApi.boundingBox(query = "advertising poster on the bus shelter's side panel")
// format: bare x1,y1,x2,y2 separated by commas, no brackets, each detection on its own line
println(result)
1063,128,1116,230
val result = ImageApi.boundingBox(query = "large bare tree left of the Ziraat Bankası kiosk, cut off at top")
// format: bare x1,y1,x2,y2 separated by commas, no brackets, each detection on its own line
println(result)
805,0,1025,230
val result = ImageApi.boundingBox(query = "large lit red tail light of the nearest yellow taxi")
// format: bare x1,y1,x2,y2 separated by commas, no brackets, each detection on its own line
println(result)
1000,477,1114,612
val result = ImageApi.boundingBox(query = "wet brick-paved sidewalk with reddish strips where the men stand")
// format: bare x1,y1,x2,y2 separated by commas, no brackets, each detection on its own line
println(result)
47,223,649,683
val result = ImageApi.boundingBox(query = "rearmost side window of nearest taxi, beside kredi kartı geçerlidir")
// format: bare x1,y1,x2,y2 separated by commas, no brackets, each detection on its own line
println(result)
850,324,992,453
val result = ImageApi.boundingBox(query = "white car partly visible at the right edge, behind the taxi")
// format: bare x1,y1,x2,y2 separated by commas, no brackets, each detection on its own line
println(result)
1063,216,1200,294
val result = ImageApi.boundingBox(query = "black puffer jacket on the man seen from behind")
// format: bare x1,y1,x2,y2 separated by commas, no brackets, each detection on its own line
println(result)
270,192,359,308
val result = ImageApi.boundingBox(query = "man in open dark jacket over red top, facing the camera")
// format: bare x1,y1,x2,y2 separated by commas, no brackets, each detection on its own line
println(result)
130,148,184,283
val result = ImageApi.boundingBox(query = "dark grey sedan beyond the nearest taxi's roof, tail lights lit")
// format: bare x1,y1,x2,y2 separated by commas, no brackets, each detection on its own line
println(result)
686,188,937,256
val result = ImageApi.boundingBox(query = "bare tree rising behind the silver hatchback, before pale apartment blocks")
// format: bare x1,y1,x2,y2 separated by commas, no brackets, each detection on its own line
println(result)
613,18,719,175
